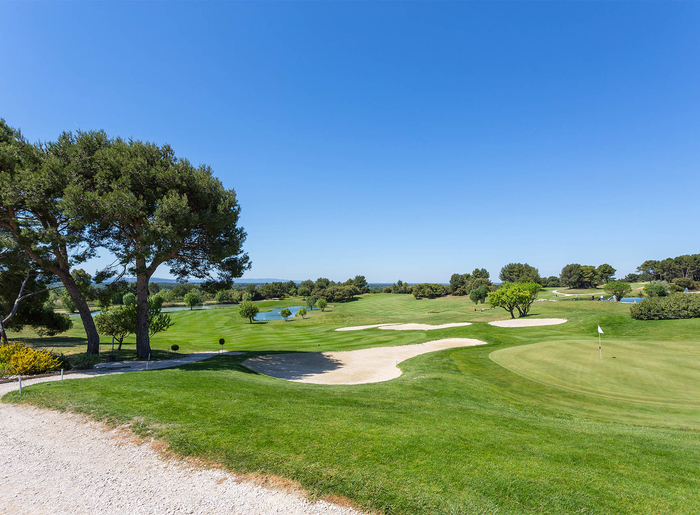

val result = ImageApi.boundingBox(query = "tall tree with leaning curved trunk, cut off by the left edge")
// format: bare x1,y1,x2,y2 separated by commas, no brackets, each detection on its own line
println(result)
0,120,107,354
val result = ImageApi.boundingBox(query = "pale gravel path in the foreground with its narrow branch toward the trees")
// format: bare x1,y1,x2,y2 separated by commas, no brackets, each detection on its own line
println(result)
0,353,360,515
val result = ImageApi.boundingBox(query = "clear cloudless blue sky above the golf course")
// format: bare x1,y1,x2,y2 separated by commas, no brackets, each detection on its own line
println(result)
0,2,700,282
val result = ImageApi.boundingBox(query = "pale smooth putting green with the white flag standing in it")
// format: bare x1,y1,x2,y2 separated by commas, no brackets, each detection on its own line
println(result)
490,339,700,406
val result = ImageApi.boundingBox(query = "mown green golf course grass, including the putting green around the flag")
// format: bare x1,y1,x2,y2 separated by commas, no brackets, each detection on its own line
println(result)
4,295,700,514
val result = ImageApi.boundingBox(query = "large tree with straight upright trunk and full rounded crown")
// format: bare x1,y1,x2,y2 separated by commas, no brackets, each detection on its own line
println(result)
63,133,250,357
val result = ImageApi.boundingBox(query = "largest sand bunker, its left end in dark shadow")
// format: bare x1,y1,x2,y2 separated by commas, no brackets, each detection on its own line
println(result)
243,338,486,384
